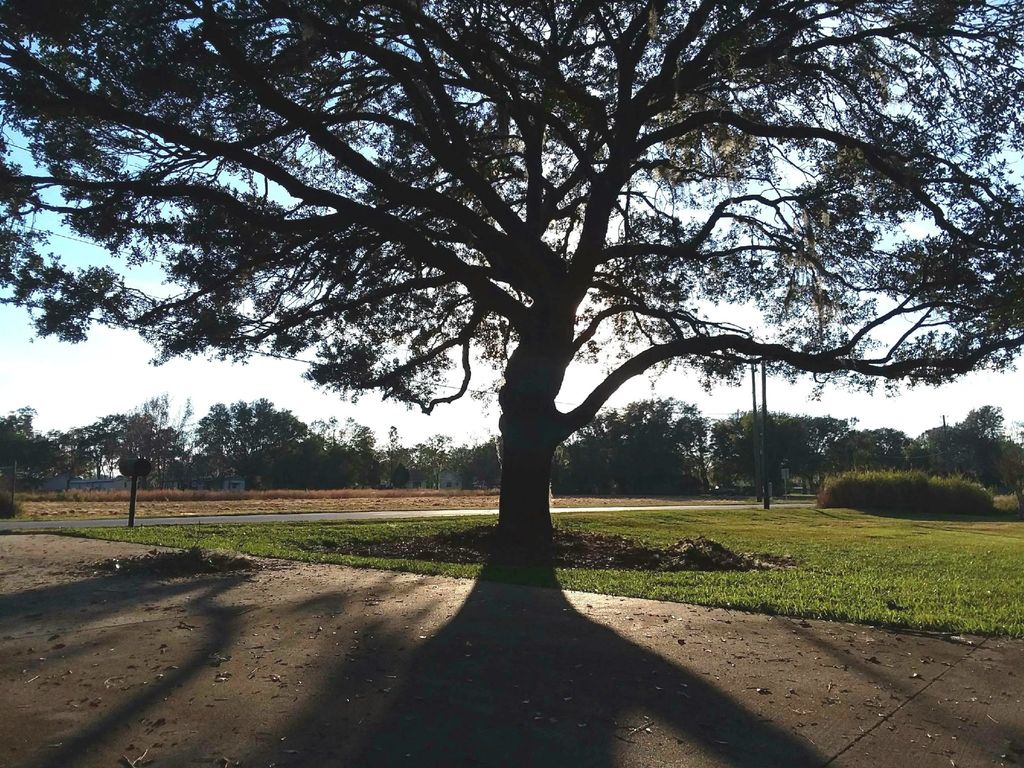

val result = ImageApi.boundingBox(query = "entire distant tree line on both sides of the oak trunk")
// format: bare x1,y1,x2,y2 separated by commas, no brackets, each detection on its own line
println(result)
0,395,1024,495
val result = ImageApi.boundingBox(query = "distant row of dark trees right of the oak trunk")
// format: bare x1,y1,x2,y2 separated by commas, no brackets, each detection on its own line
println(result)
554,399,1024,495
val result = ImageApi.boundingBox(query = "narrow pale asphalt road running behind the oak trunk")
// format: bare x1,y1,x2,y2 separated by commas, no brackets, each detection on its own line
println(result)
0,502,812,530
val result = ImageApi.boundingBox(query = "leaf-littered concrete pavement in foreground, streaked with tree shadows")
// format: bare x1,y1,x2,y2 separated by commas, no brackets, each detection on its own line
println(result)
0,536,1024,768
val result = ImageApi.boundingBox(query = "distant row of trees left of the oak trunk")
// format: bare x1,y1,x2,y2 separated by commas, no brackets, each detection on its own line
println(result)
0,395,501,488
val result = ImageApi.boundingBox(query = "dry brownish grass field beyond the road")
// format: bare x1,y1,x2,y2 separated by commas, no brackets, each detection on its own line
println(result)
14,489,735,519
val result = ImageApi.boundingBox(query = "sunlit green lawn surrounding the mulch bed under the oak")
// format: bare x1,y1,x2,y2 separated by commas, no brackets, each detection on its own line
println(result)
58,509,1024,637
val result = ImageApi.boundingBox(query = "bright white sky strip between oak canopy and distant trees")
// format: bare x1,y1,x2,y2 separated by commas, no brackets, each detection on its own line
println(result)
0,306,1024,444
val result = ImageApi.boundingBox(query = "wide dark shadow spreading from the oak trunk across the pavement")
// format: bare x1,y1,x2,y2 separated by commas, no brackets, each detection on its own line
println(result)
251,566,824,768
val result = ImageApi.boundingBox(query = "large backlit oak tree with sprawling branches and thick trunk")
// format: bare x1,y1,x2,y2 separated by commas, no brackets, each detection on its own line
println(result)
0,0,1024,549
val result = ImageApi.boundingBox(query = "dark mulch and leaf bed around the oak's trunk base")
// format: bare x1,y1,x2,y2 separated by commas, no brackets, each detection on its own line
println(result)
335,526,795,571
